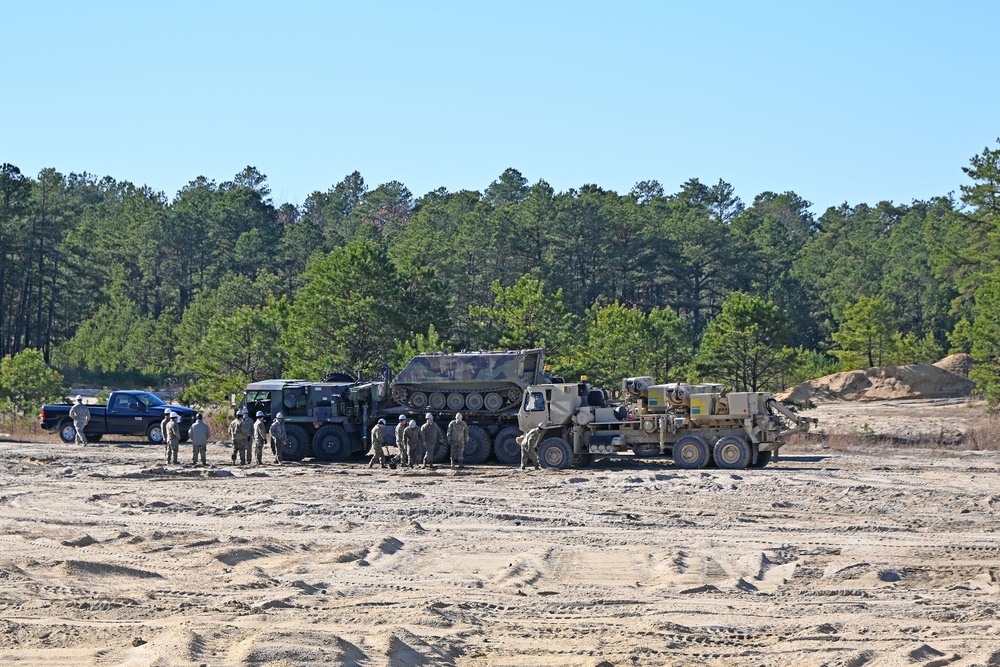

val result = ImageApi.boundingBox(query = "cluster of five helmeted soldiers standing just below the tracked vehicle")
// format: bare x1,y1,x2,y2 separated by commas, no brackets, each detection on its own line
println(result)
368,412,469,468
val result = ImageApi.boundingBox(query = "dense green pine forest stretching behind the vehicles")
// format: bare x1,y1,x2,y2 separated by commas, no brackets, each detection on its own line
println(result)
0,141,1000,409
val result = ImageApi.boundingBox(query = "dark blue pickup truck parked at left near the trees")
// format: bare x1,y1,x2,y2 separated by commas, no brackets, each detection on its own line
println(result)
40,391,197,444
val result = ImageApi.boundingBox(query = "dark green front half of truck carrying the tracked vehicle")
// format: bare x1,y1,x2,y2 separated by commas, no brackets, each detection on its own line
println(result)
240,374,393,461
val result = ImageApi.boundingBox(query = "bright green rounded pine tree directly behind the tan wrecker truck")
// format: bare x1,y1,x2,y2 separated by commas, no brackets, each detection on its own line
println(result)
697,292,791,391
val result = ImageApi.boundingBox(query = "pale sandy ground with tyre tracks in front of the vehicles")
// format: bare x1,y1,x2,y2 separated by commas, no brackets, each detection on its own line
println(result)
0,406,1000,667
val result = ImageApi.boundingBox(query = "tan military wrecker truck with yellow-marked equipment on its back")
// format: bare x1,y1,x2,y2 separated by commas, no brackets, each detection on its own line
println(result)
518,377,816,469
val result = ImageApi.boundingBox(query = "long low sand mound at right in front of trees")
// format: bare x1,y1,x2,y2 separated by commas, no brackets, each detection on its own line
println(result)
778,366,975,402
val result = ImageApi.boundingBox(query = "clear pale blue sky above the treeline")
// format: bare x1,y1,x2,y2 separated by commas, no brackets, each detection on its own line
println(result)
0,0,1000,213
